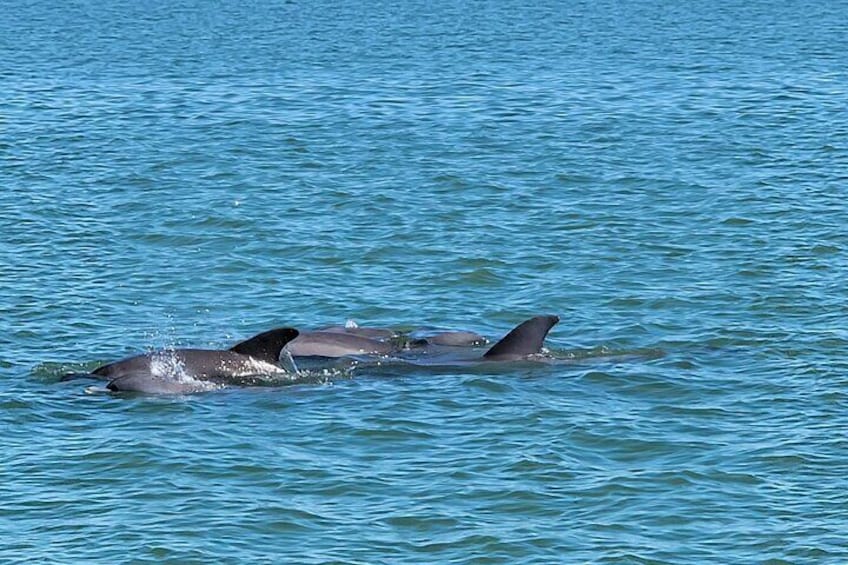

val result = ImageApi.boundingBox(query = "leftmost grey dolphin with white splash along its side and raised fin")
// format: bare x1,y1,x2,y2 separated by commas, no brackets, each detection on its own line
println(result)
86,328,299,393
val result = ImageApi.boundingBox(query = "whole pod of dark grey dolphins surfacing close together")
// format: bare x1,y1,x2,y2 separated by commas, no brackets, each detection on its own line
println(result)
62,315,559,394
